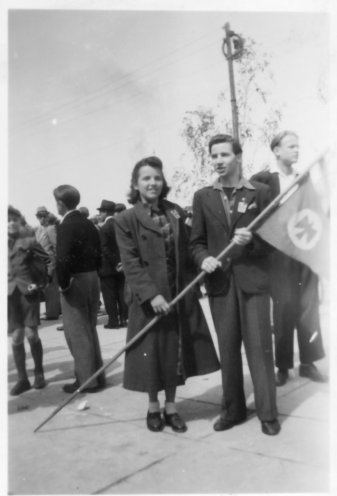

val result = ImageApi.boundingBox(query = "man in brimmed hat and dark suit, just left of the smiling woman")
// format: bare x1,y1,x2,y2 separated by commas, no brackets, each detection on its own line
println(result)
97,200,127,329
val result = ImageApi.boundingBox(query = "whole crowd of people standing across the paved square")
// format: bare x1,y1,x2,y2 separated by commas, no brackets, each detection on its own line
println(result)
8,131,327,435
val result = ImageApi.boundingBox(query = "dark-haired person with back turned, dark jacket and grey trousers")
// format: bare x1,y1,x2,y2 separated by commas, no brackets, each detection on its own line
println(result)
54,185,105,393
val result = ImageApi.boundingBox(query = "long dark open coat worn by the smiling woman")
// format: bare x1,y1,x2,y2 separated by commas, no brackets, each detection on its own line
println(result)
116,200,219,391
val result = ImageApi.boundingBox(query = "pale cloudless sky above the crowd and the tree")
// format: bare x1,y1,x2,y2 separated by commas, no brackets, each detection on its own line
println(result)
8,5,330,225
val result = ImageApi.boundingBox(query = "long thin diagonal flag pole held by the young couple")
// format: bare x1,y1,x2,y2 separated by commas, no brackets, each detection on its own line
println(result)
34,152,326,432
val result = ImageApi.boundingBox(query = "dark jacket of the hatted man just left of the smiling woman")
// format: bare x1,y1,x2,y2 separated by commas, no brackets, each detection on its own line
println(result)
99,218,121,277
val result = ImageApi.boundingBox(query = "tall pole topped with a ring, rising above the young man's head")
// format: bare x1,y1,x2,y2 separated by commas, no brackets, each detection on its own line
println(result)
222,22,243,141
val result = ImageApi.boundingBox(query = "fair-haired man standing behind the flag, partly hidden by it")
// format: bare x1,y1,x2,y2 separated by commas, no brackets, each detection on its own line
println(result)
252,131,326,386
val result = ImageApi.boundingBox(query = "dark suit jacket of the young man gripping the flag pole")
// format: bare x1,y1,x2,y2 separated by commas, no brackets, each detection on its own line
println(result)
191,182,270,296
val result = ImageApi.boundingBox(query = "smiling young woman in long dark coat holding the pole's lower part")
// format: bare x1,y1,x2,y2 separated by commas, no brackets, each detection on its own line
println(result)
116,157,219,432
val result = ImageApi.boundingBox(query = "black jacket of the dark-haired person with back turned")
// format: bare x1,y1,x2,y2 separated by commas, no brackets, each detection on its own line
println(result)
56,210,101,289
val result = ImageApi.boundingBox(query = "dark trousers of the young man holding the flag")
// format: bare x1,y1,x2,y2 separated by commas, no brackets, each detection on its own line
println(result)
210,276,277,421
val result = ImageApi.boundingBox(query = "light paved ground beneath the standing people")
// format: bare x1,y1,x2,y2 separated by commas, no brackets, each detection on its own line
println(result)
8,296,330,495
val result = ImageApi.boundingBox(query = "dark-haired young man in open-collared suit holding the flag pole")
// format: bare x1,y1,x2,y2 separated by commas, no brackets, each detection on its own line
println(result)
191,135,280,435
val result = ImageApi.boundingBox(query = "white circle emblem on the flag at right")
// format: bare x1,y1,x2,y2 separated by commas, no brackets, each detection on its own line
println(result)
287,208,323,250
